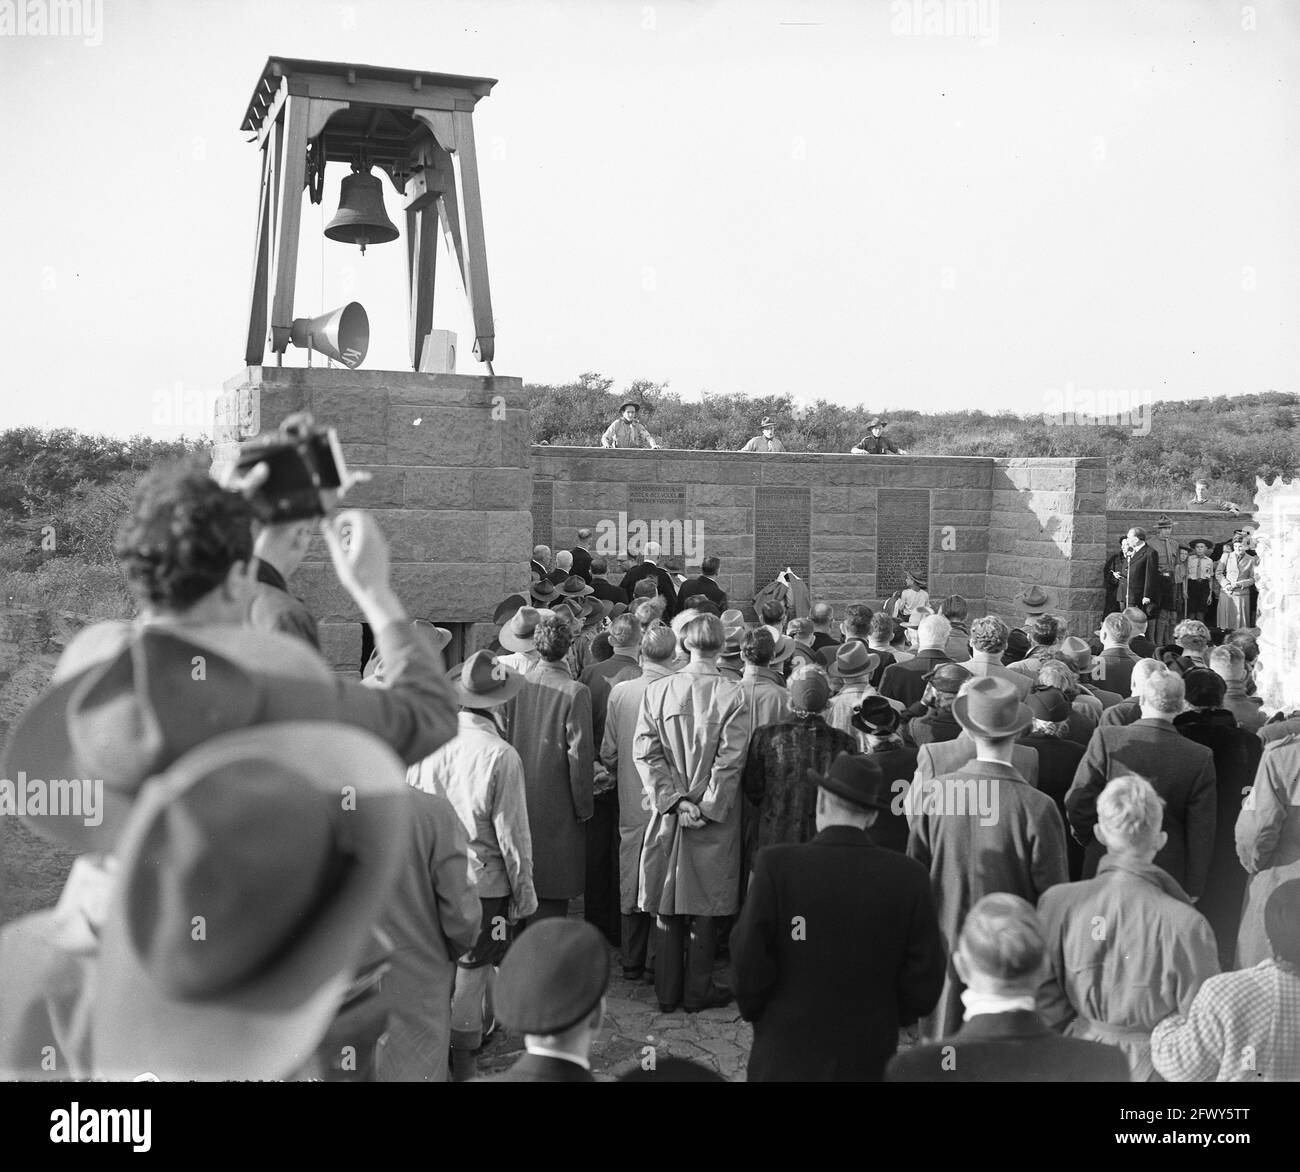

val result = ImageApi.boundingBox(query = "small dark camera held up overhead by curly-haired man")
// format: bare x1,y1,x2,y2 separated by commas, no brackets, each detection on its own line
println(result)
235,414,358,525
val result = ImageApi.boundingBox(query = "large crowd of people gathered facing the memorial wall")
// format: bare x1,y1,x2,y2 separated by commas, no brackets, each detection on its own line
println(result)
0,465,1300,1081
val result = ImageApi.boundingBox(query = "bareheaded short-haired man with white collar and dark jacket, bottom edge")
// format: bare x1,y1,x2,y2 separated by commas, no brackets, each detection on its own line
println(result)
885,893,1128,1082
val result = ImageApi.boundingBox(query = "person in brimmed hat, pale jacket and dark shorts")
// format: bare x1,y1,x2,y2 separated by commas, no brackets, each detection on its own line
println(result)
407,651,537,1082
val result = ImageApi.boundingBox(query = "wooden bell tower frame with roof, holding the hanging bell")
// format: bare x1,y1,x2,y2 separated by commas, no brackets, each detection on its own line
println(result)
241,57,497,370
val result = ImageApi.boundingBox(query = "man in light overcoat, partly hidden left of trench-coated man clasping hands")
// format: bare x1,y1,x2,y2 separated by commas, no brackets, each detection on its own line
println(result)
599,626,677,981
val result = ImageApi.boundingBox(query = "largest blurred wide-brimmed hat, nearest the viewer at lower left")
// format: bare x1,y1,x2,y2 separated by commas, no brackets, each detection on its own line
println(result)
91,721,410,1080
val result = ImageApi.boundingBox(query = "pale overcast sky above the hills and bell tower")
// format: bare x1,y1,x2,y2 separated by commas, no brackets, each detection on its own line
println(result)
0,0,1300,435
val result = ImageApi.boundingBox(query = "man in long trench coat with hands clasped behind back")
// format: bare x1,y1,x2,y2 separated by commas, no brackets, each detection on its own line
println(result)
633,615,750,1012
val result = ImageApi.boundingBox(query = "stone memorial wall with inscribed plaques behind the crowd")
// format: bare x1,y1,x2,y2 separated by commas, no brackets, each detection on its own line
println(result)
532,446,1106,641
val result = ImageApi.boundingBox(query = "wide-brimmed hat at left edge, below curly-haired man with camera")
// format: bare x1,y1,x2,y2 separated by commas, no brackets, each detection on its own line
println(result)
0,624,338,854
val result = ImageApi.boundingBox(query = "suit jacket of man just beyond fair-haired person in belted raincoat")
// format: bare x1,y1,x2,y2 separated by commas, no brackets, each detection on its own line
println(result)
1065,720,1217,895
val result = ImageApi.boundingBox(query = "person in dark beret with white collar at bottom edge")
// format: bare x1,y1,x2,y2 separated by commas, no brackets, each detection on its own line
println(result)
494,920,610,1082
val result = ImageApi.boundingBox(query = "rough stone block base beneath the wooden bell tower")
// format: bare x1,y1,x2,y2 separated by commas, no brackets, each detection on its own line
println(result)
213,366,533,636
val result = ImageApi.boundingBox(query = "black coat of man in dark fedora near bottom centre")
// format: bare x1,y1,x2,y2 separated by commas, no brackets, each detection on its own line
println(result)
731,826,946,1082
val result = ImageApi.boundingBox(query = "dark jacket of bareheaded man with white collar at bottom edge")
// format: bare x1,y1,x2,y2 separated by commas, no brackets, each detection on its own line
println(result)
885,1010,1128,1082
